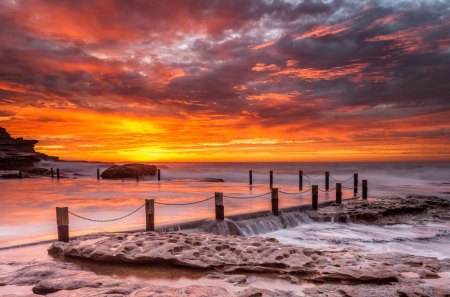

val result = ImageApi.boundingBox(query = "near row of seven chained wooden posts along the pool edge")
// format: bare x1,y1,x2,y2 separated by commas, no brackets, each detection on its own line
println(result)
56,180,367,242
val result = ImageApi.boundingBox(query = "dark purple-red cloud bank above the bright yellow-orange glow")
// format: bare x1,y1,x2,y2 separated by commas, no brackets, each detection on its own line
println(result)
0,0,450,131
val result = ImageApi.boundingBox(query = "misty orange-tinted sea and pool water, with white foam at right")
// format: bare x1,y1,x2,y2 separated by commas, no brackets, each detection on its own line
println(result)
0,162,450,249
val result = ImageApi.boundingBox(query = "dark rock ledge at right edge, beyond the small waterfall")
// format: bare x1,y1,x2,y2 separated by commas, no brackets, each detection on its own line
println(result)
309,195,450,225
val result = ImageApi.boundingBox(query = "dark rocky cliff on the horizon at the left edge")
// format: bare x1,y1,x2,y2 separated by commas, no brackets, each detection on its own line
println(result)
0,127,58,170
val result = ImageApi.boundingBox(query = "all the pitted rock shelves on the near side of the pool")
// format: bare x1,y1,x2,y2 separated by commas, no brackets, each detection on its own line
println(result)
0,196,450,297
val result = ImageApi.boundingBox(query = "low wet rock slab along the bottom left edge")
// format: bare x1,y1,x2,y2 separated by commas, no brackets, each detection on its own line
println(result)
0,262,301,297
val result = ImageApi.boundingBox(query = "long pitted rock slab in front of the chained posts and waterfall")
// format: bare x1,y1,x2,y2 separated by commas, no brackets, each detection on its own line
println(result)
49,232,450,284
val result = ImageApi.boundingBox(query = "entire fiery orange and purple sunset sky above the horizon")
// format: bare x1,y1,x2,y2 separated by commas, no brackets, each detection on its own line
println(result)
0,0,450,162
